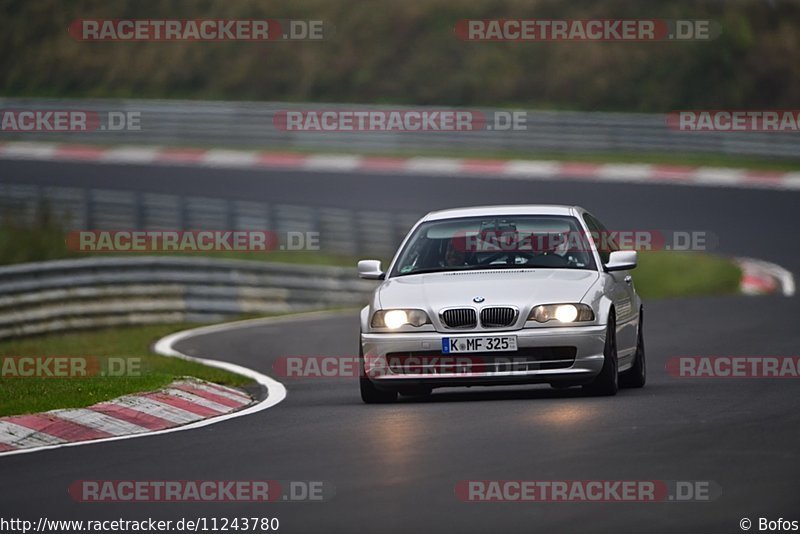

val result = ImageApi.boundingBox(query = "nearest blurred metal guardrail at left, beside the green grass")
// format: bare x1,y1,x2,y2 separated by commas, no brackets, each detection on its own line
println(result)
0,256,375,339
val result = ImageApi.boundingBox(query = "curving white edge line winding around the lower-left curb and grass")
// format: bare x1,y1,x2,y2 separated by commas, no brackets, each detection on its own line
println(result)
0,310,362,457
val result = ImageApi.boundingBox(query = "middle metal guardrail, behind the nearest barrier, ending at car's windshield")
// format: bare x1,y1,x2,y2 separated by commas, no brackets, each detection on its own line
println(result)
0,183,422,258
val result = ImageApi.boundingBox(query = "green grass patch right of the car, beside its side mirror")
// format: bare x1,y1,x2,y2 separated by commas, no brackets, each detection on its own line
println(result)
632,251,741,299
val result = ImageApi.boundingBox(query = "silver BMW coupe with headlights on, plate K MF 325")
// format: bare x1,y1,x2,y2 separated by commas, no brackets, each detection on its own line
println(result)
358,205,646,403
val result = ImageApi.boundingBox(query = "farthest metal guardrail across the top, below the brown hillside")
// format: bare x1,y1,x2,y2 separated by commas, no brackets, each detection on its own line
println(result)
0,98,800,157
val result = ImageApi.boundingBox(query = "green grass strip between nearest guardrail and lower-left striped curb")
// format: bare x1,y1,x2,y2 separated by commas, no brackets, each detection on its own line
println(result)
0,324,252,416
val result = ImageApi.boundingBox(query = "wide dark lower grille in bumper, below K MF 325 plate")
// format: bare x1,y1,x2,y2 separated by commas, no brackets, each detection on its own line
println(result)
386,347,578,376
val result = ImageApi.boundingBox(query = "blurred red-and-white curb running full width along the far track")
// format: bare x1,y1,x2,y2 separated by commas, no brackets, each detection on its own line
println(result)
0,141,800,190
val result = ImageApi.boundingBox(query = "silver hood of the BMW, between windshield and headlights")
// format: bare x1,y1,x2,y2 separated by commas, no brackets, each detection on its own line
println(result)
377,269,599,314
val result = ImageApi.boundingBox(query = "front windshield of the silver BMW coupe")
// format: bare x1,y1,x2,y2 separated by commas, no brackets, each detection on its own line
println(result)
391,215,595,276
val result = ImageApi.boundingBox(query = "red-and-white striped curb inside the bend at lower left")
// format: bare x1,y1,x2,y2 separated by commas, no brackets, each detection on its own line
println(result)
0,379,253,452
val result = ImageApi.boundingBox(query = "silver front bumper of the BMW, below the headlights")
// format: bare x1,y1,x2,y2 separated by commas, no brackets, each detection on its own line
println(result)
361,325,606,388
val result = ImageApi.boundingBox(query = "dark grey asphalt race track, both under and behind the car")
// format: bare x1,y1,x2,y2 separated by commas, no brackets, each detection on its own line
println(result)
0,161,800,532
